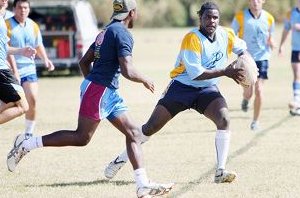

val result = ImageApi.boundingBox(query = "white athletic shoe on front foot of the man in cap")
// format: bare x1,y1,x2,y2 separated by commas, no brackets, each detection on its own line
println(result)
136,182,174,198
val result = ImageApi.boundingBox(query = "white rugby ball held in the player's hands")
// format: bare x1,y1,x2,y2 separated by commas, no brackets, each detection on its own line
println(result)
235,54,258,88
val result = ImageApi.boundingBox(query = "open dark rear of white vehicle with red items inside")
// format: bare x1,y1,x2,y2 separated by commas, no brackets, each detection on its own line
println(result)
29,6,76,59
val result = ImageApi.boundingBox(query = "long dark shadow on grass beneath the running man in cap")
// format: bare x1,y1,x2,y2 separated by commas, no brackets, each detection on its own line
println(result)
25,179,135,188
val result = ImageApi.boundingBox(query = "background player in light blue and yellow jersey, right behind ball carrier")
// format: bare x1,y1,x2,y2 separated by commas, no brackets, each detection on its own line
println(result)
231,0,275,130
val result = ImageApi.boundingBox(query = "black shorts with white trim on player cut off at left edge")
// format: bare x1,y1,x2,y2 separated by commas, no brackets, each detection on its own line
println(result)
0,69,24,103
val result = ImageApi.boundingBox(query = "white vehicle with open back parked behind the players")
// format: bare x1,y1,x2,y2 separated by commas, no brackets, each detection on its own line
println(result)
29,0,98,72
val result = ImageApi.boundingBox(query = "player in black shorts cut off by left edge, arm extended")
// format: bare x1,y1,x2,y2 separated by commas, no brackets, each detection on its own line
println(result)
0,0,36,124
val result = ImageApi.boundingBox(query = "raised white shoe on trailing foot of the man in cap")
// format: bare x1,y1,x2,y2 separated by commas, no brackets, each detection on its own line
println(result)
6,134,29,172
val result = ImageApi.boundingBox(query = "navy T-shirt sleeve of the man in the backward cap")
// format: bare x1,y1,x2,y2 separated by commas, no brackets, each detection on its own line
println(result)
116,31,133,57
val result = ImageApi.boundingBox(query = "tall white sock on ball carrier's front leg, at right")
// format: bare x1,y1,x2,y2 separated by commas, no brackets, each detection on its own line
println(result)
215,130,230,169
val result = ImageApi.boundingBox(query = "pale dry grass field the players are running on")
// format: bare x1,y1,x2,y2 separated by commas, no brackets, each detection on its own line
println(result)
0,26,300,198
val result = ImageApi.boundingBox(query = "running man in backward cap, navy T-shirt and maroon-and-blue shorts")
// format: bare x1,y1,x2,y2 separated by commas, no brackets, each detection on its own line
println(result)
7,0,174,198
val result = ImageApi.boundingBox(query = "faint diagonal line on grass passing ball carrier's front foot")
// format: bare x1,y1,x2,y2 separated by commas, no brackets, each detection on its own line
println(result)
172,115,292,197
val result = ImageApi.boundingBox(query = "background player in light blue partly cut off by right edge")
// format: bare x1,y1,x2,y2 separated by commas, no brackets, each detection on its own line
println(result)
278,0,300,115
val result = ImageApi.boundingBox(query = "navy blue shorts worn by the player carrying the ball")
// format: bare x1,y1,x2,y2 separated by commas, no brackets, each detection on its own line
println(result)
158,80,225,117
